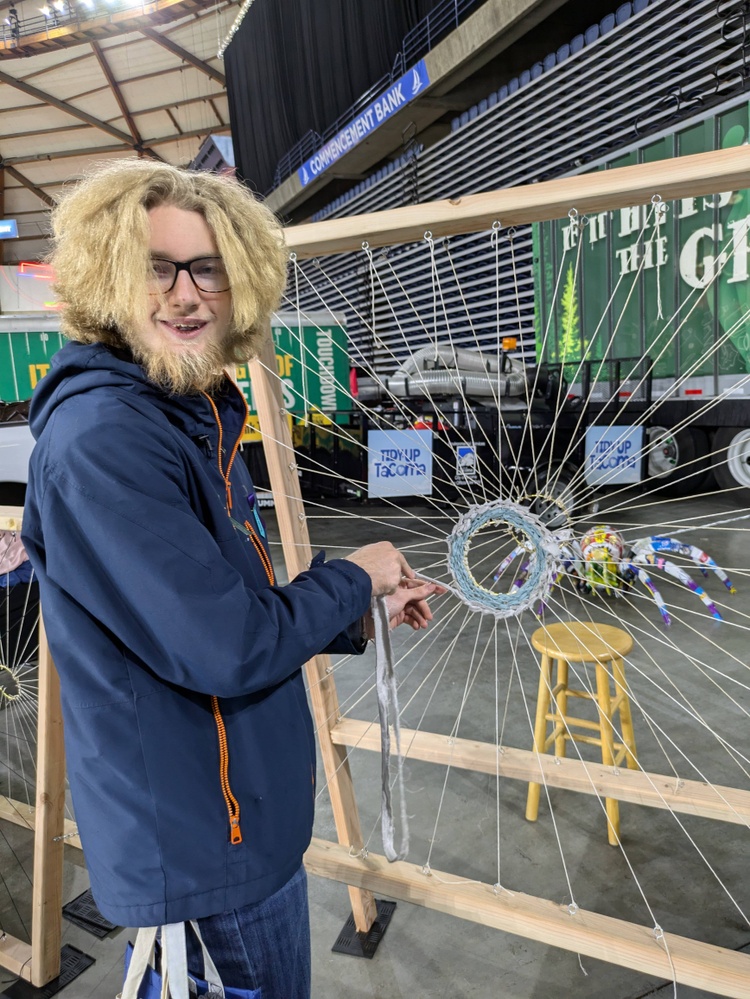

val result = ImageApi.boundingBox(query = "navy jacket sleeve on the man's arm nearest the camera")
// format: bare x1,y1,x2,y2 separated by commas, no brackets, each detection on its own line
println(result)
29,404,371,697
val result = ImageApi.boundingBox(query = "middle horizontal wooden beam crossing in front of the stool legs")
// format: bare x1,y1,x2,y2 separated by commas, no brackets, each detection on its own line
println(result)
331,718,750,826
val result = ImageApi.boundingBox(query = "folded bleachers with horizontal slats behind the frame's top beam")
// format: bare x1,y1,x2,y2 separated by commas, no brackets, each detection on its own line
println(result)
290,0,750,374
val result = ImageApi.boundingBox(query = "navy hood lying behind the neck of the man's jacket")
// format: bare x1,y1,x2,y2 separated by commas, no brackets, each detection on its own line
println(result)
29,342,245,440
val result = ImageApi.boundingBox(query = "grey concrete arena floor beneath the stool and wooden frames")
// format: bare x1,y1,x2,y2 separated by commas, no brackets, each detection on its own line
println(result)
0,488,750,999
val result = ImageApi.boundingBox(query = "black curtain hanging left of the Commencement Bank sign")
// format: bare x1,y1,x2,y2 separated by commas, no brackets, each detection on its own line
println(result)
224,0,438,193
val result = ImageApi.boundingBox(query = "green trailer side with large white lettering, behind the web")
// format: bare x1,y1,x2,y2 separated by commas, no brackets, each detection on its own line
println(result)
534,103,750,378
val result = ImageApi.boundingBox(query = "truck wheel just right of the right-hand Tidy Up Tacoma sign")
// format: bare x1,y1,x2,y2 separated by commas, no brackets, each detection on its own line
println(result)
647,427,710,496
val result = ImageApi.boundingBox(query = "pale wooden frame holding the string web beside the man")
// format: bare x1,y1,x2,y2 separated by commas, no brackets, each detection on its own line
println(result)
250,146,750,999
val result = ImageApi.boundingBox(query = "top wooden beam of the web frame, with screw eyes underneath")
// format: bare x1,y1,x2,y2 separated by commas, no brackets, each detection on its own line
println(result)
285,146,750,257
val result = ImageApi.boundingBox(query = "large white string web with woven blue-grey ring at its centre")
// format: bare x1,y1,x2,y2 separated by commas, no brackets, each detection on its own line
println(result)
251,186,750,995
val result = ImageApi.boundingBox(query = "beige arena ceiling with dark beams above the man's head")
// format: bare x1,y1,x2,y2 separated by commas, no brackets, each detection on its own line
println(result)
0,0,240,264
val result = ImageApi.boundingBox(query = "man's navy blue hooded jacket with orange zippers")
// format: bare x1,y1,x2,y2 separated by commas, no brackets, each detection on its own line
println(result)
23,343,371,926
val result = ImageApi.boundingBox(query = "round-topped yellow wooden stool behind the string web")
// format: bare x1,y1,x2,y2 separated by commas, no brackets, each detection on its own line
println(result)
526,621,640,846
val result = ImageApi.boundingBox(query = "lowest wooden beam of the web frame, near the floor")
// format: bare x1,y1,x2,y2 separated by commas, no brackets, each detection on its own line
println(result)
305,839,750,999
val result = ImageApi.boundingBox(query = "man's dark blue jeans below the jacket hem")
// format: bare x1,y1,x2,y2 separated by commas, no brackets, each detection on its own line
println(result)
188,867,310,999
